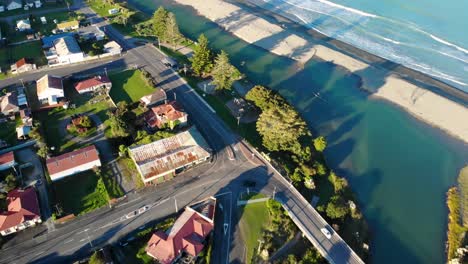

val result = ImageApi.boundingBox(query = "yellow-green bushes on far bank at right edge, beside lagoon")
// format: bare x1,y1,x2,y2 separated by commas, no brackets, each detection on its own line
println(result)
447,166,468,263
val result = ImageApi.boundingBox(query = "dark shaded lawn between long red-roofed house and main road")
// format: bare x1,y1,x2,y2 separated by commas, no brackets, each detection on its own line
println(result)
53,171,108,215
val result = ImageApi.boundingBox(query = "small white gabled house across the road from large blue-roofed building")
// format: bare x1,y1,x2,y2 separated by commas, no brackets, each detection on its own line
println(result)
37,74,64,105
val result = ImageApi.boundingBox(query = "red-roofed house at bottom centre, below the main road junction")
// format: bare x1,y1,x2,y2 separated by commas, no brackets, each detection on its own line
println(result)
145,197,216,264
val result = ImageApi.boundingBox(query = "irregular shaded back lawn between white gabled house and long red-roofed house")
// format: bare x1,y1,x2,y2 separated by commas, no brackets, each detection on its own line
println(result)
34,81,112,154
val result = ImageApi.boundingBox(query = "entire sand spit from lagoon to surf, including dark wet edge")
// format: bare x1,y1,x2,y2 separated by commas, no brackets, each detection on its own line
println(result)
170,0,468,143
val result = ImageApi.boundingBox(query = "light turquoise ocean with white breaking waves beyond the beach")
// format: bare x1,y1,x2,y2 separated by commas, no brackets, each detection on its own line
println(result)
249,0,468,92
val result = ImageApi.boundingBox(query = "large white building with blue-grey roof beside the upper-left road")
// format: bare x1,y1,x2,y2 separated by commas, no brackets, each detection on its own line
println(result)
46,36,84,65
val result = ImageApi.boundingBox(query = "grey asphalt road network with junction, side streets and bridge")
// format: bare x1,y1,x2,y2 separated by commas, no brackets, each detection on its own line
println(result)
0,1,362,263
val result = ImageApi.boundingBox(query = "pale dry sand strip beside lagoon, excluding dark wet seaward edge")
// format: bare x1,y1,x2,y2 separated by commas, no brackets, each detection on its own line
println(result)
175,0,468,143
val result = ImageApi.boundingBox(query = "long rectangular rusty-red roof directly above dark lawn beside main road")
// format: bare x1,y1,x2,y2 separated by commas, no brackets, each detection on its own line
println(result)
46,145,99,175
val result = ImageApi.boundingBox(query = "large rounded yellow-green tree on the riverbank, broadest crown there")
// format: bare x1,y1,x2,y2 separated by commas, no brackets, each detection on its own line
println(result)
257,107,308,153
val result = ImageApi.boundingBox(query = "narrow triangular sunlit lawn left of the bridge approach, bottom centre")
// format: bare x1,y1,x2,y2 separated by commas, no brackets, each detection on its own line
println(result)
239,198,270,263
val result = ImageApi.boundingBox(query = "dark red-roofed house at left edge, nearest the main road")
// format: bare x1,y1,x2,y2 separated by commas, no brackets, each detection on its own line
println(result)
0,187,42,236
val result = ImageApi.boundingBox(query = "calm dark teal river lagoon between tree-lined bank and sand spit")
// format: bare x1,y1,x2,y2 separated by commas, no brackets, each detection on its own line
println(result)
130,0,468,263
